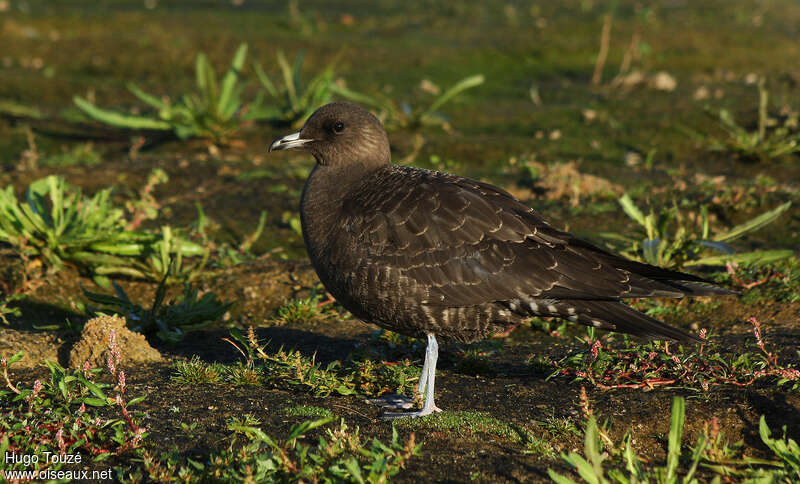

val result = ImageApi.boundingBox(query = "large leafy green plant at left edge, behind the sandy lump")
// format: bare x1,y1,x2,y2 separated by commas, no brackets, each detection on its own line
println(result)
0,175,208,286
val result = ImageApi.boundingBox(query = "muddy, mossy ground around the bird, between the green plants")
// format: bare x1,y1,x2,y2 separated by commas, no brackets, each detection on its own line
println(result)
0,0,800,482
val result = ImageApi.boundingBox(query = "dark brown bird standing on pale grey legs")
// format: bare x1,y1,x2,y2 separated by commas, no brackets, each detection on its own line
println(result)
269,102,733,417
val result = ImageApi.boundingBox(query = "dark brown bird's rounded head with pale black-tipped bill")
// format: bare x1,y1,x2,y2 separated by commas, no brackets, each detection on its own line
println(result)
269,102,391,170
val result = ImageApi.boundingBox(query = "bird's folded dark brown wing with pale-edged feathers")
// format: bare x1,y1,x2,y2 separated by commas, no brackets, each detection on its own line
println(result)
336,167,720,306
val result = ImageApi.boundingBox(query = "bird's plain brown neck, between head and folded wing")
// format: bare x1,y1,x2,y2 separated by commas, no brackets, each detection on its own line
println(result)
300,164,390,262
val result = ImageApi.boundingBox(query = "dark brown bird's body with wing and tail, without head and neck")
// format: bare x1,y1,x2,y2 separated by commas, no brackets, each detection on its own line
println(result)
312,165,728,341
